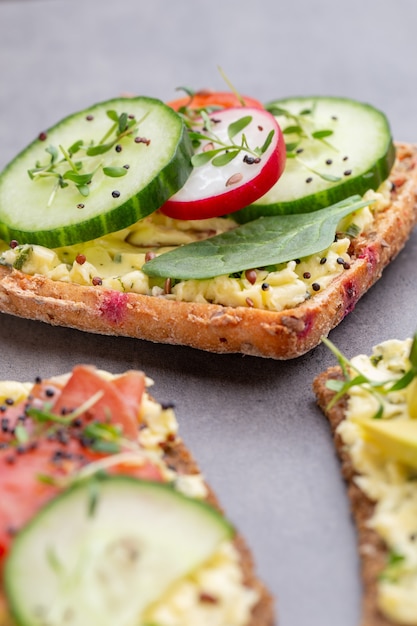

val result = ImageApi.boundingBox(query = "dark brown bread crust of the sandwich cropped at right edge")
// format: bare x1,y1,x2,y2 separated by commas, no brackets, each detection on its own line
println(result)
313,367,395,626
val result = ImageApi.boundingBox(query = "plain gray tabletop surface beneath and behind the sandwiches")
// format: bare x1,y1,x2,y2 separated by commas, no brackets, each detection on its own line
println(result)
0,0,417,626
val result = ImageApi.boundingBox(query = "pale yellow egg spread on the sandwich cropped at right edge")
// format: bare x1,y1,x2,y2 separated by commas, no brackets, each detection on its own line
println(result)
339,340,417,626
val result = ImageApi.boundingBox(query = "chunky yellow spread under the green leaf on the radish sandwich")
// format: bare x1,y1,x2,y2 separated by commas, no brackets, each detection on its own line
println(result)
0,185,389,311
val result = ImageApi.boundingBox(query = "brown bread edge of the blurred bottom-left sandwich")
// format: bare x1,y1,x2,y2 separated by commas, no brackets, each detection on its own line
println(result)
165,439,277,626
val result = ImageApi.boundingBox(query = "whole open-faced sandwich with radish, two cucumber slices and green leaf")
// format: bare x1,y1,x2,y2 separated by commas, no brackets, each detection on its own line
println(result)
0,92,417,359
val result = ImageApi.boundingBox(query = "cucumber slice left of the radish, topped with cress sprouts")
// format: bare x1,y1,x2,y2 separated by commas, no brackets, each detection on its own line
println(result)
0,97,193,248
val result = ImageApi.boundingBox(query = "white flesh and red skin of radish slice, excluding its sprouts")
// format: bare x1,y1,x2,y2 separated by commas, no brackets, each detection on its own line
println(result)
161,107,286,220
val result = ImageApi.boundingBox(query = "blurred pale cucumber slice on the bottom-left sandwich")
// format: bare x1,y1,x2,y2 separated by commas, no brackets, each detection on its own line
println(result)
5,476,233,626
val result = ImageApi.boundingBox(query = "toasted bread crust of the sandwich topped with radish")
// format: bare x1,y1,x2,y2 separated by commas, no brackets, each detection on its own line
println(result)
0,144,417,359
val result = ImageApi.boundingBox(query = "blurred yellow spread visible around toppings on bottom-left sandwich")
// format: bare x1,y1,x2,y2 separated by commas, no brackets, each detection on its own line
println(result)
0,371,259,626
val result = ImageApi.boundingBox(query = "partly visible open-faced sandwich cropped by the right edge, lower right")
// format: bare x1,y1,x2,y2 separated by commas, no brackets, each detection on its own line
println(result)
314,335,417,626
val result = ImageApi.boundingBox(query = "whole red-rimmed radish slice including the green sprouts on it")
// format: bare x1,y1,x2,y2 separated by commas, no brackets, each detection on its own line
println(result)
161,107,286,220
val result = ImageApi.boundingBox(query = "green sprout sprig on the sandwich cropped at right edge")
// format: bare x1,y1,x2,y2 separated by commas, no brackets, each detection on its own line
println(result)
321,333,417,419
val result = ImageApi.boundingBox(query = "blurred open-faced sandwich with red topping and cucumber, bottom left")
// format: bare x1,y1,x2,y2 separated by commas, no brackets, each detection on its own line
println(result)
0,365,275,626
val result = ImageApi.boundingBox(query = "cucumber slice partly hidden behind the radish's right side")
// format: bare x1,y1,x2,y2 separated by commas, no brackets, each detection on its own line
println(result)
233,97,395,223
